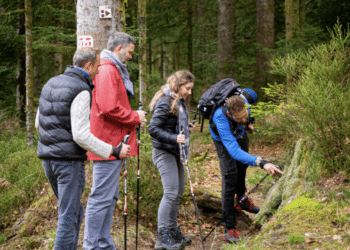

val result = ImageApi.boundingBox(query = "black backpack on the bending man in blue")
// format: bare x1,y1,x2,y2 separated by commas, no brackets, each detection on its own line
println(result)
197,78,242,122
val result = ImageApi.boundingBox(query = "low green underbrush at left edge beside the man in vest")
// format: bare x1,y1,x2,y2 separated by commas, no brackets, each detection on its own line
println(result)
0,119,46,229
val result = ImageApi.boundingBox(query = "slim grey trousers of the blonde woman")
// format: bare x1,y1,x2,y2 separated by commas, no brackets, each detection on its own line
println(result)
152,148,185,232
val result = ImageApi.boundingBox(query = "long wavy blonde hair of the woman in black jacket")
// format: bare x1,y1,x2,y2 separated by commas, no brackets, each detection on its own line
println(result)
149,70,195,115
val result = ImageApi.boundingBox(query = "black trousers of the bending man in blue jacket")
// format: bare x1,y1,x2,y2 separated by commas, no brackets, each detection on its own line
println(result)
213,133,249,229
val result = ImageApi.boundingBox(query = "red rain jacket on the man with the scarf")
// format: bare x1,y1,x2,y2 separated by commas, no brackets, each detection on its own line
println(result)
87,58,140,161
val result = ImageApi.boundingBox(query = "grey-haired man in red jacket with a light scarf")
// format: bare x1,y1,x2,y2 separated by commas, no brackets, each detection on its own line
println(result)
83,32,146,250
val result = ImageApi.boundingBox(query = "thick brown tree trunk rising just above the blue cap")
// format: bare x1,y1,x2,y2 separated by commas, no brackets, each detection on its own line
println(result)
255,0,274,90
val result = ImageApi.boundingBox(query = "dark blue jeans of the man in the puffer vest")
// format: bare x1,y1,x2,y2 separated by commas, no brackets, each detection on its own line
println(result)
43,160,85,250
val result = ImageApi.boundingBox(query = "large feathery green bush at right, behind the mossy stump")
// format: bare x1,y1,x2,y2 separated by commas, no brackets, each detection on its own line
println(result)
253,25,350,174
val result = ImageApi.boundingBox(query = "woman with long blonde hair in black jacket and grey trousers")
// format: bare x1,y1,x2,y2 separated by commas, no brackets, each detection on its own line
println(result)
148,71,195,249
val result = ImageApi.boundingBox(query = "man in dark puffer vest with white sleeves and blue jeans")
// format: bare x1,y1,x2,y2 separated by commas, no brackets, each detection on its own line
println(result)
35,48,131,250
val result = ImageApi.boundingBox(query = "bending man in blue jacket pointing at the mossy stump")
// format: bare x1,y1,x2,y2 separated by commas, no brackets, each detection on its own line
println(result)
210,89,283,243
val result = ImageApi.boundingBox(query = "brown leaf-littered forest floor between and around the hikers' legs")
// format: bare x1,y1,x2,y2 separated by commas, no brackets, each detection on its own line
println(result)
0,123,288,250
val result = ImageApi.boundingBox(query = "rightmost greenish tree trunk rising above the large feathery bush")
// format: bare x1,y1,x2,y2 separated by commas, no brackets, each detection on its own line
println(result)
285,0,305,40
